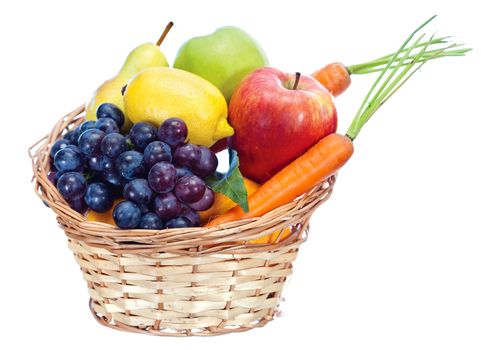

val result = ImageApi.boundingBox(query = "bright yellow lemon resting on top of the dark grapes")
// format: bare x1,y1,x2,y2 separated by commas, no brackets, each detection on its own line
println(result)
124,67,234,147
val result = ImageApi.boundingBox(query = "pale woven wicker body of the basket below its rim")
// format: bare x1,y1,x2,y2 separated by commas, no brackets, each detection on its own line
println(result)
69,235,304,336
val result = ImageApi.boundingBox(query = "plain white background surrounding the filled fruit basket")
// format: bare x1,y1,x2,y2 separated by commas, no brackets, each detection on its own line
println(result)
0,0,481,350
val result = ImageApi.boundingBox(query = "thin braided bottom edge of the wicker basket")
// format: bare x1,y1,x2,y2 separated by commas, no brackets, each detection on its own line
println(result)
89,298,274,337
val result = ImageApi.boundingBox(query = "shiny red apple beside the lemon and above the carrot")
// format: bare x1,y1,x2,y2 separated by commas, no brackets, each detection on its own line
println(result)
229,67,337,182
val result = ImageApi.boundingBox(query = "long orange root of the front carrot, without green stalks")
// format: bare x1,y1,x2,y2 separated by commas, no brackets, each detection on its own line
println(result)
206,134,354,226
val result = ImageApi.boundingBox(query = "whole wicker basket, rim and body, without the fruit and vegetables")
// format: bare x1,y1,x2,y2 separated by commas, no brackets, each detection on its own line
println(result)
29,106,335,336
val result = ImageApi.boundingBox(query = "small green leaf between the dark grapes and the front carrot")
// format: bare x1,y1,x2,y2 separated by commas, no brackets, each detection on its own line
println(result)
205,148,249,213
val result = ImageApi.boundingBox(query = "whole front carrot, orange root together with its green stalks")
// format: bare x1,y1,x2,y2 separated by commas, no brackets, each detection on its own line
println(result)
206,16,466,227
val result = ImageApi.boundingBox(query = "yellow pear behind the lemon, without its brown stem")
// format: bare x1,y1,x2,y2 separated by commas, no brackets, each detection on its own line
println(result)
85,43,169,131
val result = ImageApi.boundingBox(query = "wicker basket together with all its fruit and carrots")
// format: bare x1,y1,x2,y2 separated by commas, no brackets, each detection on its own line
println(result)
29,17,469,336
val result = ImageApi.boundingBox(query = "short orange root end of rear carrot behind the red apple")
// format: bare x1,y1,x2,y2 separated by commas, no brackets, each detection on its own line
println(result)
311,62,351,96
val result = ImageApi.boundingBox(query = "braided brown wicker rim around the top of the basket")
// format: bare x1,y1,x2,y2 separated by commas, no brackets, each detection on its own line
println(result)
28,105,336,255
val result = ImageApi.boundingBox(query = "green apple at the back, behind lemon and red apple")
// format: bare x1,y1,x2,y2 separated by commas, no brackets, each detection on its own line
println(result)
174,26,268,101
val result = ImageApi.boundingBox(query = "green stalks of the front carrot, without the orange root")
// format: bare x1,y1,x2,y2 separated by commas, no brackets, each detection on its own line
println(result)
346,16,470,140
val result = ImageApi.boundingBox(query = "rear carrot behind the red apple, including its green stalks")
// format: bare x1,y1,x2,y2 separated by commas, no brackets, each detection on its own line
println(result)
311,30,471,96
